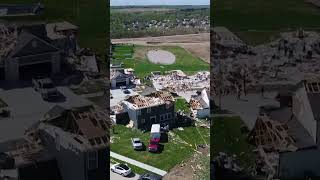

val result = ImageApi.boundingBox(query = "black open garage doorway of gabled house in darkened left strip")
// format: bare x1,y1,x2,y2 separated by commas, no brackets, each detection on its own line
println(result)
19,62,52,80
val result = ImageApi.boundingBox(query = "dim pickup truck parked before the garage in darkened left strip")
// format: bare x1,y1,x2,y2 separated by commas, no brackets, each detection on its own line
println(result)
32,78,59,100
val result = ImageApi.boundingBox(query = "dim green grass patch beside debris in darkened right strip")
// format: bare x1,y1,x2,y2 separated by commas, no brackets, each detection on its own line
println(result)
211,117,255,168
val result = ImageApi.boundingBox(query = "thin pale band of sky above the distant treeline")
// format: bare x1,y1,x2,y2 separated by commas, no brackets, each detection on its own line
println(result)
110,0,210,6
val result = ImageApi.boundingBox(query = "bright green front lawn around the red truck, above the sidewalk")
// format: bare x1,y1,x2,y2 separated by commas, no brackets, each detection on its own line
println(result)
111,125,210,171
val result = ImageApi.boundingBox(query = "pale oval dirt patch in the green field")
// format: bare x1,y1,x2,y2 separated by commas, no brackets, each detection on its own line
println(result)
147,50,176,65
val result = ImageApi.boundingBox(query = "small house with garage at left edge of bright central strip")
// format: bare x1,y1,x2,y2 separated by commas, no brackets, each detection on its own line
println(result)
110,70,134,89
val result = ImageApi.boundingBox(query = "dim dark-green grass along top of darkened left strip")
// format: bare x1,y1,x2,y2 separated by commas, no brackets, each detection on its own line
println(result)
0,0,109,57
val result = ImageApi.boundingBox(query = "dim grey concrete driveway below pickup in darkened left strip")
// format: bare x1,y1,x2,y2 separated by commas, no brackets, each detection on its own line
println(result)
0,87,92,146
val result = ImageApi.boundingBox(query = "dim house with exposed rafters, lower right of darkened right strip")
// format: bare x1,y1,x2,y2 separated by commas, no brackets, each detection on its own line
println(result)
249,78,320,179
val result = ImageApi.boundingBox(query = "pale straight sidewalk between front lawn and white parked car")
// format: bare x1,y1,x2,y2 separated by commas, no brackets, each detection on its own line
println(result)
110,152,167,176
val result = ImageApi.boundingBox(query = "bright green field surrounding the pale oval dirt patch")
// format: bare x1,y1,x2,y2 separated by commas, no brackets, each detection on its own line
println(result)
113,46,209,78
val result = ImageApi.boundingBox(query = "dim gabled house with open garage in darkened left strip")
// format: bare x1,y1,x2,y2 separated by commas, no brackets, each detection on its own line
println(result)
0,22,78,80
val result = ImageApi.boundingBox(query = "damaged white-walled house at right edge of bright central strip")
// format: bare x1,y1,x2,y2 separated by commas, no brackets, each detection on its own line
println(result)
189,89,210,118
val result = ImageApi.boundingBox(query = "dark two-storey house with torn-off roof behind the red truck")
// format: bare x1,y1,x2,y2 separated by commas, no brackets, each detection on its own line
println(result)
123,91,175,130
